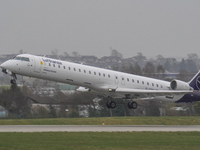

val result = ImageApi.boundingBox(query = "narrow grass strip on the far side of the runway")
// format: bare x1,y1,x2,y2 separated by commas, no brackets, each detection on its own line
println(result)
0,117,200,125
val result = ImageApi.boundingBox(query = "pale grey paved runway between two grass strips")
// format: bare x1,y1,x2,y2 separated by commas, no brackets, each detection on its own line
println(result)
0,125,200,132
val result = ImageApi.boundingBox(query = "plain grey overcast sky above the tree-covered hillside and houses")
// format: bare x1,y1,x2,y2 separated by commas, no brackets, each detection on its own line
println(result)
0,0,200,58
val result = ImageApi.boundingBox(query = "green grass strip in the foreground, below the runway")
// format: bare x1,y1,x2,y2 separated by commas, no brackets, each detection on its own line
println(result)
0,132,200,150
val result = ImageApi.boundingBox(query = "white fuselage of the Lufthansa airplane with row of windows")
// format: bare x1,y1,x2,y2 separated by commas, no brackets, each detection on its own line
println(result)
0,54,183,101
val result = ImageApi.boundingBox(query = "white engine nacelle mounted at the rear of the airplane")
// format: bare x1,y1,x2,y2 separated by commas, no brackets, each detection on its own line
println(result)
170,80,192,90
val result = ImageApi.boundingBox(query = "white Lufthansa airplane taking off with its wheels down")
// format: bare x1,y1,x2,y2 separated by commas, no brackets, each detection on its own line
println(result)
0,54,200,109
